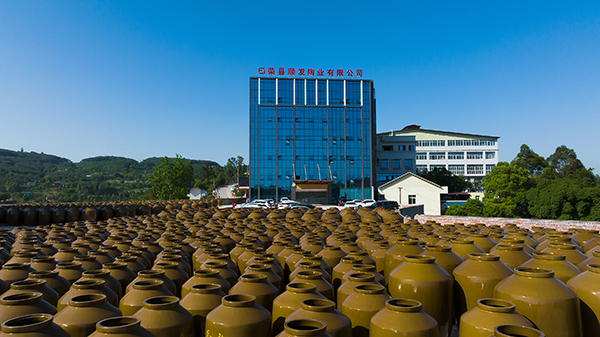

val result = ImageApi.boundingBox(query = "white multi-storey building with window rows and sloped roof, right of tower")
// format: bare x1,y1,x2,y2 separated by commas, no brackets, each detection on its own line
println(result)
378,125,500,181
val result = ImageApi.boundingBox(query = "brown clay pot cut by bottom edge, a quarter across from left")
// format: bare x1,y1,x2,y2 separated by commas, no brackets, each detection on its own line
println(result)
133,296,194,337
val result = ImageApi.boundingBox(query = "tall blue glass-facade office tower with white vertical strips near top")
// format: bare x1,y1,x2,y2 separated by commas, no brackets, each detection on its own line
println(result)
250,77,375,203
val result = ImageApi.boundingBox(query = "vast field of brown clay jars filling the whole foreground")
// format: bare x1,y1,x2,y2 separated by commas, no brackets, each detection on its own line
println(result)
0,201,600,337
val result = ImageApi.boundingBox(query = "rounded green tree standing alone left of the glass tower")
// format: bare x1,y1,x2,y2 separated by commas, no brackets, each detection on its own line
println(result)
148,154,194,200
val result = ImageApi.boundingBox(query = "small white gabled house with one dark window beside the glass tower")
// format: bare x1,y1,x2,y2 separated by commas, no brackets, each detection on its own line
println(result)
378,172,448,215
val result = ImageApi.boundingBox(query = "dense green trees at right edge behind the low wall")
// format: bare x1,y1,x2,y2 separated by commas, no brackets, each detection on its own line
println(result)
445,144,600,221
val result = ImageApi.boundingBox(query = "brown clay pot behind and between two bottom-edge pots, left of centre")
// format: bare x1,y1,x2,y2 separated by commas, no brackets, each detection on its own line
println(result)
181,283,225,335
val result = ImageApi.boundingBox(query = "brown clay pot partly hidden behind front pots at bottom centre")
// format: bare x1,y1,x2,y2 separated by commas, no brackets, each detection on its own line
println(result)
271,282,326,334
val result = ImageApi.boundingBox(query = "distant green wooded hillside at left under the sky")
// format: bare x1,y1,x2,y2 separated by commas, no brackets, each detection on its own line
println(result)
0,149,221,203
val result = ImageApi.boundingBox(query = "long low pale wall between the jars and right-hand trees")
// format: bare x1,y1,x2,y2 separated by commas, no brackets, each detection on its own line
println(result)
415,214,600,230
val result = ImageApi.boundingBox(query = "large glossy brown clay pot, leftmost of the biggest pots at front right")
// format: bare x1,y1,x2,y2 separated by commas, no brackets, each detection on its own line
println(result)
388,255,453,337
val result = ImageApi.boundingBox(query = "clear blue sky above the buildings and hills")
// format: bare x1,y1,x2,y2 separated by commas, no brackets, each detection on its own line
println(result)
0,0,600,174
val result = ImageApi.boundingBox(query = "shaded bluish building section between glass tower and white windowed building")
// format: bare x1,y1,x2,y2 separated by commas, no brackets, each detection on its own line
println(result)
375,135,417,186
